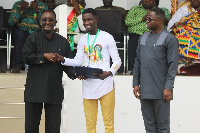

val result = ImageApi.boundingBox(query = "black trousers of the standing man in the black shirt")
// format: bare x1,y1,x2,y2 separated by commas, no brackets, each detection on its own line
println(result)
25,102,62,133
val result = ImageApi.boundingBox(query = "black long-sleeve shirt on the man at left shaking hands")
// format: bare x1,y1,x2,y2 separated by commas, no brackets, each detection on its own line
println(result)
22,31,75,103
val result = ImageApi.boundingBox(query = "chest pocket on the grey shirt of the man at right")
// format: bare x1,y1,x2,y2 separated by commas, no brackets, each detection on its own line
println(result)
152,45,167,59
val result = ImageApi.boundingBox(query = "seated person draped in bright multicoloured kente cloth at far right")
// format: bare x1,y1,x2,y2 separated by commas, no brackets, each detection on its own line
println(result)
167,0,200,72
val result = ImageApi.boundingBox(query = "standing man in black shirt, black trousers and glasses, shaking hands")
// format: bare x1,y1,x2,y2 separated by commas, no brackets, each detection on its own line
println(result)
22,10,75,133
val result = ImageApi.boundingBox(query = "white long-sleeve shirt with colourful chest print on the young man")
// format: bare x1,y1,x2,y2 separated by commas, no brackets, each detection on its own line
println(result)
62,30,121,99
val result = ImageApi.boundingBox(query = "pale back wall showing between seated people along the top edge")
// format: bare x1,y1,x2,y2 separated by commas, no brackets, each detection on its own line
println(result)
0,0,171,10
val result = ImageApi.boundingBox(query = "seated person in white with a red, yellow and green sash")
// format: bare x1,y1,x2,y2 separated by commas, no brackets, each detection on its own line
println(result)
54,0,85,51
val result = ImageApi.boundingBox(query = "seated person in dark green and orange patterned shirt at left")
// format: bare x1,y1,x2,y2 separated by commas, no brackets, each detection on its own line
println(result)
8,0,48,73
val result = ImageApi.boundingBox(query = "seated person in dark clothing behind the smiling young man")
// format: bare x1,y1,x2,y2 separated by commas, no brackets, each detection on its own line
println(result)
95,0,127,31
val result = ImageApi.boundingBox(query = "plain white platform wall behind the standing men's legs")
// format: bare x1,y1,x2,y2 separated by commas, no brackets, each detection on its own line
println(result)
63,76,200,133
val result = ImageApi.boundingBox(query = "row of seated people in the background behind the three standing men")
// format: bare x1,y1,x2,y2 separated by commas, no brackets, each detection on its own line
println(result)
0,0,200,75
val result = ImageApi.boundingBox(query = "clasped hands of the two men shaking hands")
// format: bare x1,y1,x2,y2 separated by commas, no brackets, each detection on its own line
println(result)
44,53,65,63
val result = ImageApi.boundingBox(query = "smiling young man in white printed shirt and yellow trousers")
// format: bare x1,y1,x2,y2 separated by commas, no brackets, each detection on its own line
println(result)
56,8,121,133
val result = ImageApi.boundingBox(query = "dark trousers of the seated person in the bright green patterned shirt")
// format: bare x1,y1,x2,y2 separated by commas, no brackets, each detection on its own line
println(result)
128,33,140,71
